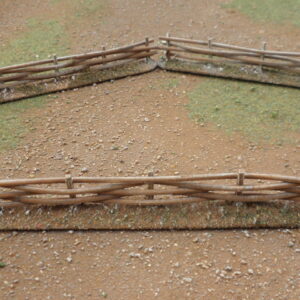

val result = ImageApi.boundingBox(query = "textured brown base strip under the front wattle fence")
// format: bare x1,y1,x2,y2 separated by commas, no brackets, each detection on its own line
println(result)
0,201,300,230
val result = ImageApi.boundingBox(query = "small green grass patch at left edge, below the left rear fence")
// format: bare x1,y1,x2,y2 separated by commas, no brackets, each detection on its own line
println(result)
0,96,47,151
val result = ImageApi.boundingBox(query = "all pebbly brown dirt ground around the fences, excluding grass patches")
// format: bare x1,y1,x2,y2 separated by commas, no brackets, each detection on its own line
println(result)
0,0,300,299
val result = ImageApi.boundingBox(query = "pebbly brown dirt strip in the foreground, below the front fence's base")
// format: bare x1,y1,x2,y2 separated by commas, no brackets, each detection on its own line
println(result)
0,230,300,300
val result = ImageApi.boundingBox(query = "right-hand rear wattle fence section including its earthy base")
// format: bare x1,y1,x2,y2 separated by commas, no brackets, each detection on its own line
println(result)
158,36,300,87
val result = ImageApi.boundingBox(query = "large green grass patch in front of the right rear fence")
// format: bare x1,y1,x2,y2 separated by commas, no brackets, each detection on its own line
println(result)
187,79,300,143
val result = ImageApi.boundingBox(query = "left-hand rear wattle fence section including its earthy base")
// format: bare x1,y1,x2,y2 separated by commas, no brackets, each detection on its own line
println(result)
0,38,156,103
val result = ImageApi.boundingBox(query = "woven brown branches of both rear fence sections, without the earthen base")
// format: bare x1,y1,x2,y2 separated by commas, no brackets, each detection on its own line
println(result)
0,36,300,94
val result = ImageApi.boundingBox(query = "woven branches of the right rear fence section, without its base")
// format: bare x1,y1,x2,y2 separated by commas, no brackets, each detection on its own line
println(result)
159,35,300,74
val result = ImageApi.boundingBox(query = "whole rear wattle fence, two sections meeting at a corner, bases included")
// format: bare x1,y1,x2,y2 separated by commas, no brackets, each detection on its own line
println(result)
0,35,300,103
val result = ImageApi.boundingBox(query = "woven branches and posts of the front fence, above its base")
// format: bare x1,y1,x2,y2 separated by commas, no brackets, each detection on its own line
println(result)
0,172,300,207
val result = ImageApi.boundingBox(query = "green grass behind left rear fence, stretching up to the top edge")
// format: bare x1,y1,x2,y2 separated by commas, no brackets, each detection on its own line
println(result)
0,0,104,66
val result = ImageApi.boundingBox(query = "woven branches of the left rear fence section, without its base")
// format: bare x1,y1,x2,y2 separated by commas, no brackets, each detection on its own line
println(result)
0,38,155,90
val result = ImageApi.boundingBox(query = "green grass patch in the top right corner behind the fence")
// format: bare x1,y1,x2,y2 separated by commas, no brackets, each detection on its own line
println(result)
222,0,300,26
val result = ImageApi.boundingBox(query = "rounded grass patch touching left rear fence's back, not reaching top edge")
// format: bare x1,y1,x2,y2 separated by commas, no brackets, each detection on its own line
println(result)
0,19,69,66
